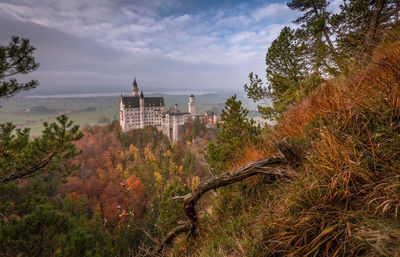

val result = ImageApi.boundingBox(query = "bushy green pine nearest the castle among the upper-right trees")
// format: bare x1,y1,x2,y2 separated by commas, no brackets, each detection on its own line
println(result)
244,27,312,118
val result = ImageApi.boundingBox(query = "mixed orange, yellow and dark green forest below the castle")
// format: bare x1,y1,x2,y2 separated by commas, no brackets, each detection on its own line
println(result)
0,117,215,256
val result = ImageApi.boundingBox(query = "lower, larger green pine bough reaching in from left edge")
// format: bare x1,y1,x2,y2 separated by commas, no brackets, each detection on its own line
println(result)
0,115,82,183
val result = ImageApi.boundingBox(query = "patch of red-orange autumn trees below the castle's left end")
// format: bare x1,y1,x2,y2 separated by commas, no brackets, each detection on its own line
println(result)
59,126,145,228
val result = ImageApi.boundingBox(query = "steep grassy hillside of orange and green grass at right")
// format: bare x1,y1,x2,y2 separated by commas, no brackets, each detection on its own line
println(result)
162,29,400,256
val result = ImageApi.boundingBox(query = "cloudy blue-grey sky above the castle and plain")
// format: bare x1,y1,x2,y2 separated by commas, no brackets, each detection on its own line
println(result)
0,0,298,92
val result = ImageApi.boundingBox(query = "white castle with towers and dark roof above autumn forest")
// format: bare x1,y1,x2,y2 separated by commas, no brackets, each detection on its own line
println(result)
119,78,196,142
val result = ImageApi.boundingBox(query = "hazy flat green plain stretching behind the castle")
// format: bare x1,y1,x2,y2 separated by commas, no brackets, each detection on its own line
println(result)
0,95,230,136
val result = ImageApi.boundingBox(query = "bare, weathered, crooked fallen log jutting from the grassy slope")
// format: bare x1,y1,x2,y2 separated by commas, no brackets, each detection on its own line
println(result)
152,138,301,256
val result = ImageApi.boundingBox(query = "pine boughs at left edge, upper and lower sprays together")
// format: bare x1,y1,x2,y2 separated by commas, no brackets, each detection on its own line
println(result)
0,37,83,184
